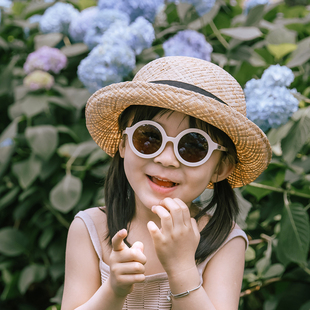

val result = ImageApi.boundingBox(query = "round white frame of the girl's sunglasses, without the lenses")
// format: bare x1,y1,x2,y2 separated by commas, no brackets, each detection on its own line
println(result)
123,120,227,167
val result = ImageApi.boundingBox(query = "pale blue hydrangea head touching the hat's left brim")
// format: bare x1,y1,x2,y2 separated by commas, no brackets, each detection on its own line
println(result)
77,41,136,93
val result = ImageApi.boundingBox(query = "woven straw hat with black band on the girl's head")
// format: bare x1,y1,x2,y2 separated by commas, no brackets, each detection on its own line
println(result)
86,56,271,187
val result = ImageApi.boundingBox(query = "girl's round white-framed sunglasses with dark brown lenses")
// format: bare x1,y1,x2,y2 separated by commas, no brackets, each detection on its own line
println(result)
123,121,227,167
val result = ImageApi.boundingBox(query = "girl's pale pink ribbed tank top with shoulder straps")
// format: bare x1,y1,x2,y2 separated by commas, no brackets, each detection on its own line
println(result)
75,211,248,310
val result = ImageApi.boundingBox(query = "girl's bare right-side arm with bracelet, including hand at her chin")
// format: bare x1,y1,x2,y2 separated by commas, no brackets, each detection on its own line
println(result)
148,198,245,310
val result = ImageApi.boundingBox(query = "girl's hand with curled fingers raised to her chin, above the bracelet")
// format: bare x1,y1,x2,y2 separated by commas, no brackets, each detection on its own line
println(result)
148,198,200,275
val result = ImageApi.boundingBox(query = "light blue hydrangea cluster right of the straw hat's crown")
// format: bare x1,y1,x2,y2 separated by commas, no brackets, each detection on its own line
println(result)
244,65,299,131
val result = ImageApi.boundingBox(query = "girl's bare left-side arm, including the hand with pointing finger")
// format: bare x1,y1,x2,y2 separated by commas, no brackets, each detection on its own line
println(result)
61,219,145,310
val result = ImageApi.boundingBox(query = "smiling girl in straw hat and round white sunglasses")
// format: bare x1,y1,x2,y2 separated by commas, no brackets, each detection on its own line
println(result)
62,57,271,310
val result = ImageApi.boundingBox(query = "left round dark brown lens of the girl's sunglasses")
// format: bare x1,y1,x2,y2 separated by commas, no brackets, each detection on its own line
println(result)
132,125,162,155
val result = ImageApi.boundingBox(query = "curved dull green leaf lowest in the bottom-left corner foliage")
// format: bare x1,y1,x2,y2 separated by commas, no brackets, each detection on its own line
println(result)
18,265,46,294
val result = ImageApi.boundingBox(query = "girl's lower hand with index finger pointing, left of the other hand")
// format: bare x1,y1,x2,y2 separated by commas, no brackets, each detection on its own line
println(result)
110,229,146,296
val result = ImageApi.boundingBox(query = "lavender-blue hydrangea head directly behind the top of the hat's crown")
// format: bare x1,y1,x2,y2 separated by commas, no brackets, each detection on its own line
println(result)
163,30,213,61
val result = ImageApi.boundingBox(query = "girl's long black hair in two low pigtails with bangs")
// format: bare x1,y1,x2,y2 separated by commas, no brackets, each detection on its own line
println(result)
105,105,239,264
